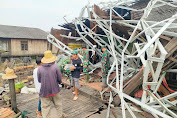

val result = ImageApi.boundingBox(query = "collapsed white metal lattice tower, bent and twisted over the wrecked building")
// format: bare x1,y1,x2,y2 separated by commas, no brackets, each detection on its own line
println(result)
47,0,177,118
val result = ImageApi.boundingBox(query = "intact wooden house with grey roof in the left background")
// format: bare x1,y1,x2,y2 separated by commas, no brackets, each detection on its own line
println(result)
0,25,57,58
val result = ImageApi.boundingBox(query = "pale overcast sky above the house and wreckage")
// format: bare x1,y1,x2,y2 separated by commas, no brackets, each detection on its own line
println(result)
0,0,118,31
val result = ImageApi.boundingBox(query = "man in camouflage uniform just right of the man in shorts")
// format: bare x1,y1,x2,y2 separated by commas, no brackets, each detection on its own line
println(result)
82,46,89,82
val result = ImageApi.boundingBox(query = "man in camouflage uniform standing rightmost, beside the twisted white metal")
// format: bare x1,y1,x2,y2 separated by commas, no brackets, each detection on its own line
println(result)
101,46,110,88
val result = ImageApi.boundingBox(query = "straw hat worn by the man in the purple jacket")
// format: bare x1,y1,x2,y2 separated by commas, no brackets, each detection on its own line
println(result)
41,50,57,63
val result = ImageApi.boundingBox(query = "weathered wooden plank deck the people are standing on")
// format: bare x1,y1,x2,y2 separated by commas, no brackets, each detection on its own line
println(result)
17,87,144,118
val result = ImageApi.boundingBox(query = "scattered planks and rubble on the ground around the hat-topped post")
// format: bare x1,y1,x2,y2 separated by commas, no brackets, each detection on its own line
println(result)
0,59,36,118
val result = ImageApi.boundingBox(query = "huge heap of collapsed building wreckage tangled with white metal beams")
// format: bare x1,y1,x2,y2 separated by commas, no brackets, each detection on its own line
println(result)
48,0,177,118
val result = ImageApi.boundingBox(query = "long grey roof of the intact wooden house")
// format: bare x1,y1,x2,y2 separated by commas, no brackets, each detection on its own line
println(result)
0,25,48,39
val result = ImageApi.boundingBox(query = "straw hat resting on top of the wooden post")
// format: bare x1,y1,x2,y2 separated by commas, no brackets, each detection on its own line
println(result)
2,67,17,79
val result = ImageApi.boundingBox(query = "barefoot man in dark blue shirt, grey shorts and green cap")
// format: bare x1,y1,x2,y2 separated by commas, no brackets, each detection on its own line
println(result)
70,50,83,100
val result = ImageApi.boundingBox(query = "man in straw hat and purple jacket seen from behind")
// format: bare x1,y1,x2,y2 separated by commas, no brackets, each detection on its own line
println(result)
37,51,63,118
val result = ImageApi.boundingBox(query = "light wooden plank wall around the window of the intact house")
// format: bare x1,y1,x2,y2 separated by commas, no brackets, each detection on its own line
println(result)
11,39,47,56
